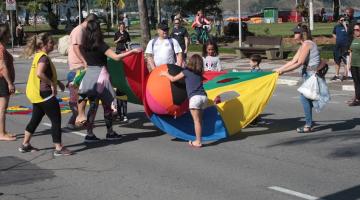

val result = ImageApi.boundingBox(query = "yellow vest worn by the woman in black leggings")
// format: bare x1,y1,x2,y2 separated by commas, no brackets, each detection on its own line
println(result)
26,51,57,103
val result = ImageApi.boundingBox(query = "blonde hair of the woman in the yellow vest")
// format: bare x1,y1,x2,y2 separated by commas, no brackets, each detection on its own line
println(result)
24,33,55,58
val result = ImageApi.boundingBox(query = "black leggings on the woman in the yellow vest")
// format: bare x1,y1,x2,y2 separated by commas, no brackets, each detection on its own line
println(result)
25,97,61,144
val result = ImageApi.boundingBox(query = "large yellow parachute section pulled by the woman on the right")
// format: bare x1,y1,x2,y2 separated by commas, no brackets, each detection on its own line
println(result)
206,73,279,135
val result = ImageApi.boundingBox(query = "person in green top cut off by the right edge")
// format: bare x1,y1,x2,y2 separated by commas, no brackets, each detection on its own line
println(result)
348,23,360,106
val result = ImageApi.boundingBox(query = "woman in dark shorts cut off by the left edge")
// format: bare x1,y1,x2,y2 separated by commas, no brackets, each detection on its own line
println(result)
0,24,16,141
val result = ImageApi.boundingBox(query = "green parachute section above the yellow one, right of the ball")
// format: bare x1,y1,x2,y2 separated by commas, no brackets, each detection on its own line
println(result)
204,72,273,90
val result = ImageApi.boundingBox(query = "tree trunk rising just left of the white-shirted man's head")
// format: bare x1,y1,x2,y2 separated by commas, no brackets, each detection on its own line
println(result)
138,0,151,48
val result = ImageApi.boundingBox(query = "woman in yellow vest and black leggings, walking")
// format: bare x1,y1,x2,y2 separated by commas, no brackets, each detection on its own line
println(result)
19,33,72,156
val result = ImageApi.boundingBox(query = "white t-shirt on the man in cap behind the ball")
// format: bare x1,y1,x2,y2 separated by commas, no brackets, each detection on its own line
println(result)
145,38,182,66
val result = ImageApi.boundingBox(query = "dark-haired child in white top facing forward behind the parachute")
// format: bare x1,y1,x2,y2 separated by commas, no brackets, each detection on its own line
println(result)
203,40,222,72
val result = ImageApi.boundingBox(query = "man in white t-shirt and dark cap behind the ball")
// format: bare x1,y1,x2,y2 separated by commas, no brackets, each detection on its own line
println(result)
145,23,182,70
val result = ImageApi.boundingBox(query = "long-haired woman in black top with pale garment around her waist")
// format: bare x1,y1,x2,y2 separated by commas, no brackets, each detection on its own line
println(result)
79,21,141,142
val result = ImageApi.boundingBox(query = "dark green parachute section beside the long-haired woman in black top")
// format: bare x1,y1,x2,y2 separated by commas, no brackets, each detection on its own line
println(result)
107,58,142,104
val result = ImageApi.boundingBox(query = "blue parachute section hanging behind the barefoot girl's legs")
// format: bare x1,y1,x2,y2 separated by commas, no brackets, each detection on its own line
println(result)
150,106,228,141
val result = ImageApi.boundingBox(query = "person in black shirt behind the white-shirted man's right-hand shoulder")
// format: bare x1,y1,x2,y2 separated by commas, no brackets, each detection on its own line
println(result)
170,18,190,63
